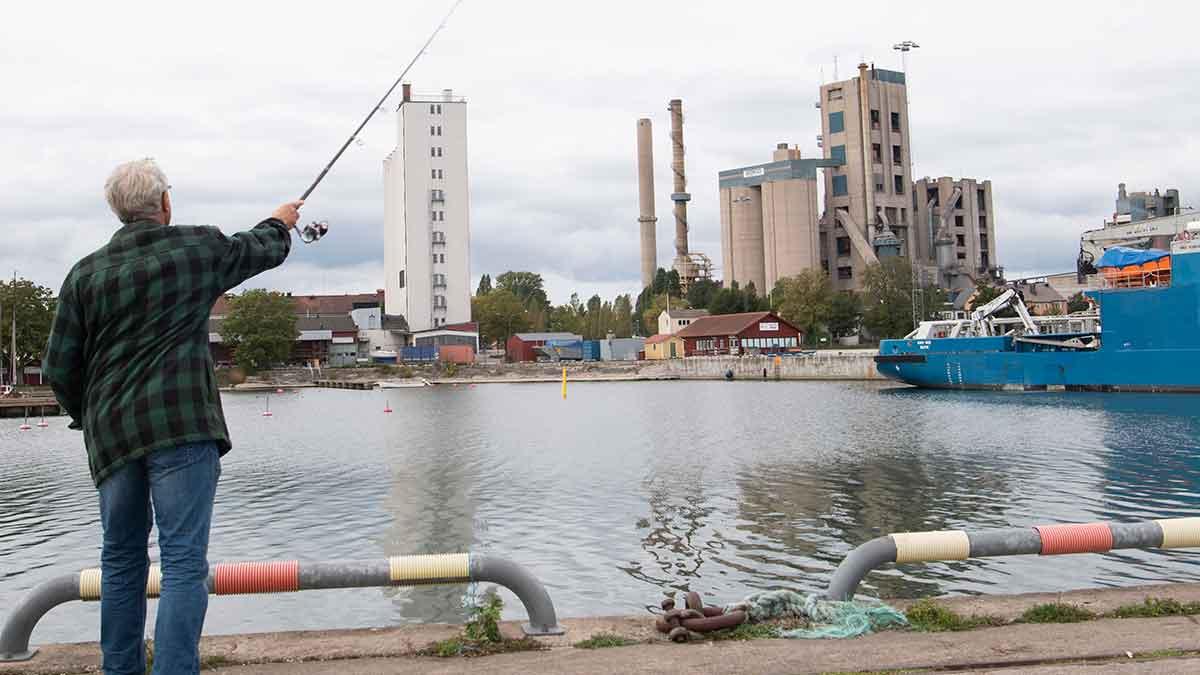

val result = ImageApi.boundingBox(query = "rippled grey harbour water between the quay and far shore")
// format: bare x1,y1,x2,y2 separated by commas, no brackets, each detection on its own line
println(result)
0,382,1200,641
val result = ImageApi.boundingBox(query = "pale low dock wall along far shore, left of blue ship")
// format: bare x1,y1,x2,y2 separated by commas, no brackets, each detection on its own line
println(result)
652,350,884,380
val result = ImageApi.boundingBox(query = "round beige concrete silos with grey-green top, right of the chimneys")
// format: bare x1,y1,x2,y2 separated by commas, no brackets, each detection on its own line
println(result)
718,143,842,294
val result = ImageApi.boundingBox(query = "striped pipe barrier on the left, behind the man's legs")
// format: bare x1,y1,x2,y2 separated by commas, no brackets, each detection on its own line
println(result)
0,554,565,662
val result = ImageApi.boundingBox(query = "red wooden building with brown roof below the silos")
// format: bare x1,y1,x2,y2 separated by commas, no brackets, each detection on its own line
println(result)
676,312,804,357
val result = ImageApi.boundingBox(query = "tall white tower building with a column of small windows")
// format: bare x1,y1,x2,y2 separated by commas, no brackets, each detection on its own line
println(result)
383,83,470,339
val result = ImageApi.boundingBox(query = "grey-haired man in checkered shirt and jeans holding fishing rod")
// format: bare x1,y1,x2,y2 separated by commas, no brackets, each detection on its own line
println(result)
42,160,302,675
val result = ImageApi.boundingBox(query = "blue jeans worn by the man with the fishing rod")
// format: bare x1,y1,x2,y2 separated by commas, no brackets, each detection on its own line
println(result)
100,442,221,675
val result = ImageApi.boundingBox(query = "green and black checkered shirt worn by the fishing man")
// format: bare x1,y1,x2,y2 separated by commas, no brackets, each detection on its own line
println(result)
42,219,292,486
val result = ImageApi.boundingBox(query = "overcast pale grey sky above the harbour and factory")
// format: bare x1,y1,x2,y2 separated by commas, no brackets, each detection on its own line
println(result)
0,0,1200,301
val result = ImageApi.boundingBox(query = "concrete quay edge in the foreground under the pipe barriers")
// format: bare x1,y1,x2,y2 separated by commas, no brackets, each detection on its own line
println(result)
7,584,1200,675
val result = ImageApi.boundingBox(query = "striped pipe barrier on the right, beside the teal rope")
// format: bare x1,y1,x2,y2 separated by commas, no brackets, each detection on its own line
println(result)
826,518,1200,601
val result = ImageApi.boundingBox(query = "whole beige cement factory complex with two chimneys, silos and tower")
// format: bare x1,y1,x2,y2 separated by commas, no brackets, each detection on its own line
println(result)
637,62,1003,300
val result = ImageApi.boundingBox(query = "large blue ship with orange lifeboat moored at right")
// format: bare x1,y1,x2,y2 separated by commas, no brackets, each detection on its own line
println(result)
875,234,1200,392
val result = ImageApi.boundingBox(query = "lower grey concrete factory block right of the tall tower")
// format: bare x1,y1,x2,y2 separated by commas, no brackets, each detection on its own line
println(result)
910,177,1001,283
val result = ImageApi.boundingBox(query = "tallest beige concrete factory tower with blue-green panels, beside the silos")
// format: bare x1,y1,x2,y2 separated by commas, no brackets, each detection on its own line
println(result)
817,64,913,291
